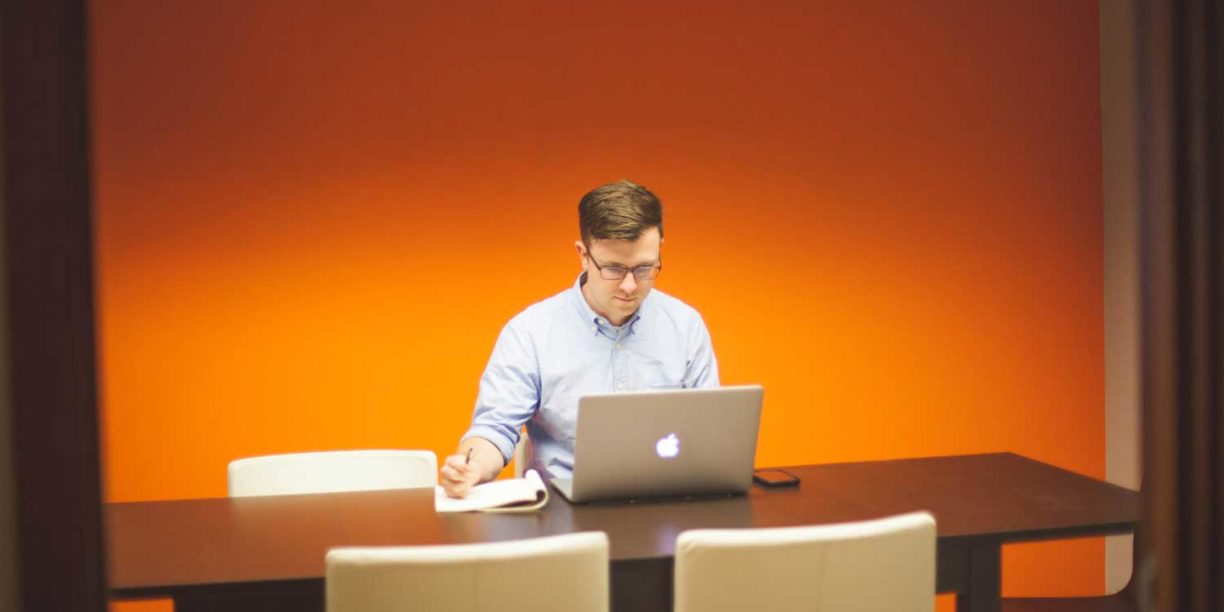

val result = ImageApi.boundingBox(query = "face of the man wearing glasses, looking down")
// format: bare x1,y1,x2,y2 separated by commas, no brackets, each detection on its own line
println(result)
575,228,662,327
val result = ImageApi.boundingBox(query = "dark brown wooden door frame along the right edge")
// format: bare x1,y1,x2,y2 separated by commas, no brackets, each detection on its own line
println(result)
1137,0,1224,611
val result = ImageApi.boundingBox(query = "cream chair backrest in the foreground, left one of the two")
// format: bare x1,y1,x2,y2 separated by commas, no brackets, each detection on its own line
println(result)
327,531,608,612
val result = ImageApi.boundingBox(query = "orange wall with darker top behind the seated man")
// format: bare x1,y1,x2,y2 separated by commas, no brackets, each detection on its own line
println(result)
91,0,1104,603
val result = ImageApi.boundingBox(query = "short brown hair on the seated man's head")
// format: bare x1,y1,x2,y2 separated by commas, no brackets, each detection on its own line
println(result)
578,179,663,246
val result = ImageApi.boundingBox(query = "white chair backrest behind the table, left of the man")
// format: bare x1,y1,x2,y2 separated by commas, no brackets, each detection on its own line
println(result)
229,450,438,497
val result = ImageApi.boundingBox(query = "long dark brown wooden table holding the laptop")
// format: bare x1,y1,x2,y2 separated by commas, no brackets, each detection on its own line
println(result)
105,453,1138,612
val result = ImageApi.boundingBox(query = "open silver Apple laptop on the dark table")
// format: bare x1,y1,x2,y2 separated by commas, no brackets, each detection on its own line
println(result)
552,386,764,502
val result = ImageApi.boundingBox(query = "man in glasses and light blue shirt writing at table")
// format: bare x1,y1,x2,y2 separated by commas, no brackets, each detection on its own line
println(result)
441,180,718,497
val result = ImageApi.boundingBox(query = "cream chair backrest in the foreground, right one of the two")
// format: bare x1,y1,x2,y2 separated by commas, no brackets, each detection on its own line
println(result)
676,513,935,612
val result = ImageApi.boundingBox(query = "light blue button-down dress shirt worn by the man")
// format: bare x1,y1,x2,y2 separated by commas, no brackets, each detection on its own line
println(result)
464,273,718,477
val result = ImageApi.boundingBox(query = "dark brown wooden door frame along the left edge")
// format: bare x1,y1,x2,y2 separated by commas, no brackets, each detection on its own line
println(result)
0,0,106,611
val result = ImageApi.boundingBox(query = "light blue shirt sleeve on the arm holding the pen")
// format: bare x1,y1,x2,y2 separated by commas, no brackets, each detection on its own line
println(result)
460,321,540,463
